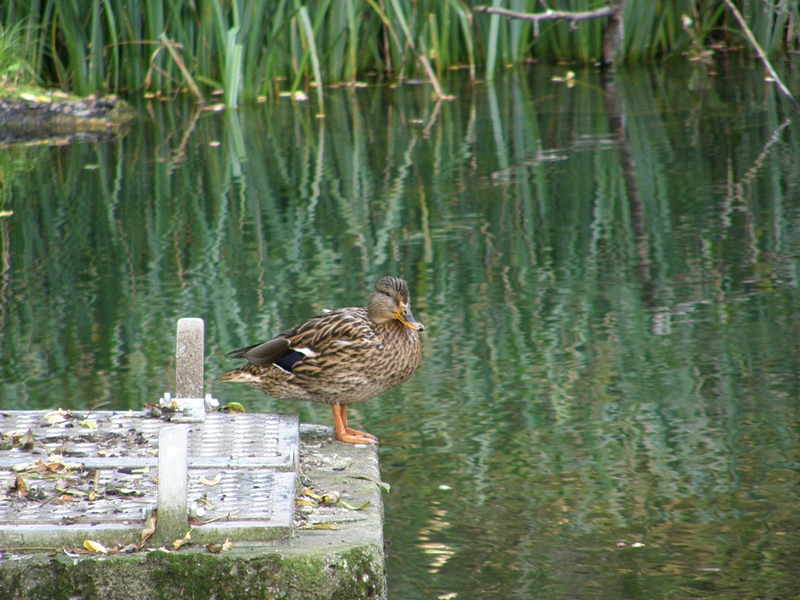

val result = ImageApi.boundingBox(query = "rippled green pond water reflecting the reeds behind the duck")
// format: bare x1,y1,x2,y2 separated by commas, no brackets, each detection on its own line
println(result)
0,62,800,600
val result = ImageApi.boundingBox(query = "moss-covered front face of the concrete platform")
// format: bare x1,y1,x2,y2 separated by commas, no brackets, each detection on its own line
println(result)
0,548,385,600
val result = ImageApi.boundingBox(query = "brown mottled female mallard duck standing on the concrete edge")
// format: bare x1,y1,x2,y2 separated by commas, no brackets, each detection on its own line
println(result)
219,277,424,444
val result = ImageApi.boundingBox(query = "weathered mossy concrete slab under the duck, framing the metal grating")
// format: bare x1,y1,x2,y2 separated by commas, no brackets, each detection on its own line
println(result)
0,426,386,600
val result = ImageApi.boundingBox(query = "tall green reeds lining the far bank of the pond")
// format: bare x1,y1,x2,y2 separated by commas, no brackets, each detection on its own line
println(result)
0,0,800,102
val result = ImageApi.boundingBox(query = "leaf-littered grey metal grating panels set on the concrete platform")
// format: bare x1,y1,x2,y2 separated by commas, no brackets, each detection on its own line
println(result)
0,411,299,546
